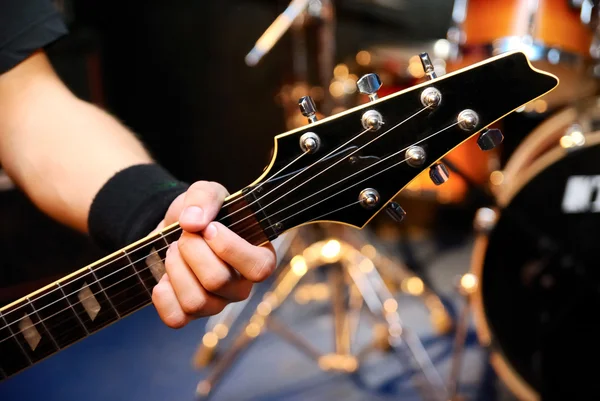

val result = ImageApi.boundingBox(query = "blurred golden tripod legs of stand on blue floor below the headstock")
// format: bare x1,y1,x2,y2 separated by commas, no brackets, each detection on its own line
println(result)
197,239,447,401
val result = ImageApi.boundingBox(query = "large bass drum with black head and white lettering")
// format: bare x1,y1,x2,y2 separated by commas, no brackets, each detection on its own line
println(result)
472,131,600,400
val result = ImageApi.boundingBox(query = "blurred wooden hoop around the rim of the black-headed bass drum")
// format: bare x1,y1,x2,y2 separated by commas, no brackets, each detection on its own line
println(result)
470,131,600,401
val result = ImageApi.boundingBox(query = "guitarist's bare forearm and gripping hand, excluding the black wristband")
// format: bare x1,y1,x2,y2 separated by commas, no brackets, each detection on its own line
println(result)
0,51,276,328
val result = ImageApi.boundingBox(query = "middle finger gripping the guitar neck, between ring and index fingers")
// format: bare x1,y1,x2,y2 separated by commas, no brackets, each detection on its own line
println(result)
177,228,252,301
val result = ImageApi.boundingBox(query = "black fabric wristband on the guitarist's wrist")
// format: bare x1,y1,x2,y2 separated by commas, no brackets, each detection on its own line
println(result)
88,164,189,251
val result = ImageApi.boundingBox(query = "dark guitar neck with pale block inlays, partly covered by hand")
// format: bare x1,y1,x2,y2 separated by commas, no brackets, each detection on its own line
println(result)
0,189,272,381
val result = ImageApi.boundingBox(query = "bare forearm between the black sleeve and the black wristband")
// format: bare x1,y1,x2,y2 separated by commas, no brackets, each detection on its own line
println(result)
0,50,151,232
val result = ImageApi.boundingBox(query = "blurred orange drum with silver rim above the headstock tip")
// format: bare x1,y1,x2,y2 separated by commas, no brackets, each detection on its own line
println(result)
447,0,600,114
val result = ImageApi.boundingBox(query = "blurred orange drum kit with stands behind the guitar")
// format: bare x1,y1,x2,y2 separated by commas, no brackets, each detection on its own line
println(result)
195,0,600,400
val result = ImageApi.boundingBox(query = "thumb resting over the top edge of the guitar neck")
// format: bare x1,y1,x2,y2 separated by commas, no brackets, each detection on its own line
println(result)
179,181,228,233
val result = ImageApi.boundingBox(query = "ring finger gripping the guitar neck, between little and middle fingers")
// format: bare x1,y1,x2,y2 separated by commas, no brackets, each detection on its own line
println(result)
165,241,227,317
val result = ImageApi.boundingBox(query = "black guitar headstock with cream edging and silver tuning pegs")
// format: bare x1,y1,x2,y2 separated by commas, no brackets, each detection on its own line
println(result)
229,48,558,238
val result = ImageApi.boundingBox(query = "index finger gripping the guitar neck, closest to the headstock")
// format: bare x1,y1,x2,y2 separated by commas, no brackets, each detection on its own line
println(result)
202,222,277,282
